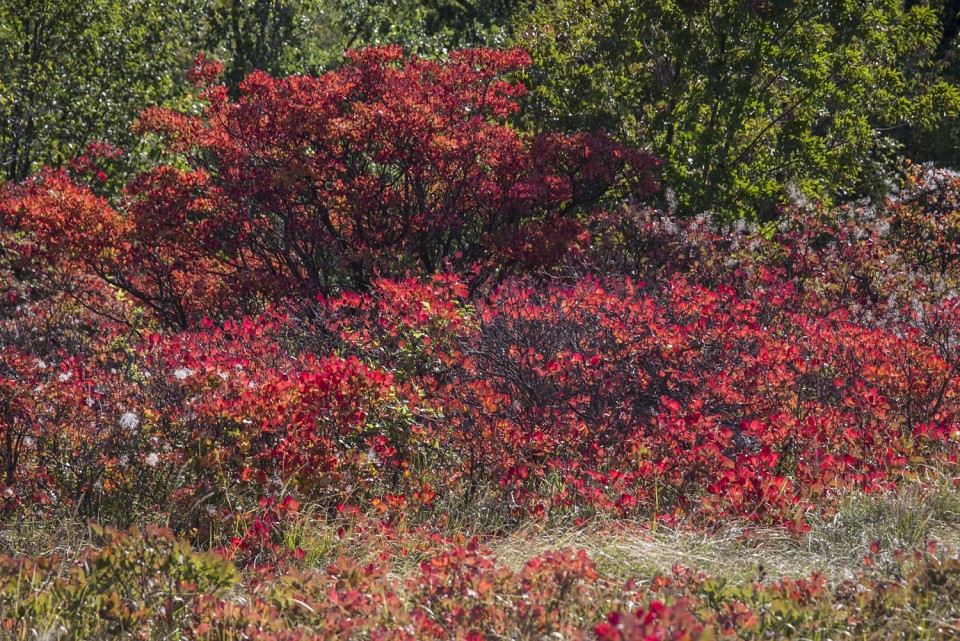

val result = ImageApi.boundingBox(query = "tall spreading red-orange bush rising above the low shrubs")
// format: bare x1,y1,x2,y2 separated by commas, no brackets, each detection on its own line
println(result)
4,47,656,328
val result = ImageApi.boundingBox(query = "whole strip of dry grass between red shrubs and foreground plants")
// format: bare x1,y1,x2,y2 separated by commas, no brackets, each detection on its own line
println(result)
0,472,960,583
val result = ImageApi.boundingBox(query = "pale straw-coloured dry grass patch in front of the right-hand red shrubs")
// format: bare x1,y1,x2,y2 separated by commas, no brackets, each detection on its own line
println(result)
492,479,960,582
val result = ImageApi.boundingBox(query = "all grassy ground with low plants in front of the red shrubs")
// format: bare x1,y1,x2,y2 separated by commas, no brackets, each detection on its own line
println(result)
0,478,960,640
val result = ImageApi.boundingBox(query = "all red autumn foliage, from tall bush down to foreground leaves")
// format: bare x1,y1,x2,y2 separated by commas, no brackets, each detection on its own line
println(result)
0,48,960,640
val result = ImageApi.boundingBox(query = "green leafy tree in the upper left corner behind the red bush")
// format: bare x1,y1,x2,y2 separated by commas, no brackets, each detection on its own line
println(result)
0,0,198,180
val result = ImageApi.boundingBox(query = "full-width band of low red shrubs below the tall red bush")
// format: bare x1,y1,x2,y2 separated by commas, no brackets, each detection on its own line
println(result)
2,159,960,536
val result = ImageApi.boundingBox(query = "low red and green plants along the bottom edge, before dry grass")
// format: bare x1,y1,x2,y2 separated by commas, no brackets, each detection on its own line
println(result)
0,529,960,641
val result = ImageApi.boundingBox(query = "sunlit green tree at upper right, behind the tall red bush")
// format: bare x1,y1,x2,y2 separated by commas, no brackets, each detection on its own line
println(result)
518,0,960,218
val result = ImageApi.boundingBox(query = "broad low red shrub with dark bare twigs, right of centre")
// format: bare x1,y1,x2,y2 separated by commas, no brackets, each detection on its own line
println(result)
323,260,958,523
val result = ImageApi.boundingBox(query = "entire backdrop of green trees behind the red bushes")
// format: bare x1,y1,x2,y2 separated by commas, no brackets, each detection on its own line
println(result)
9,0,960,219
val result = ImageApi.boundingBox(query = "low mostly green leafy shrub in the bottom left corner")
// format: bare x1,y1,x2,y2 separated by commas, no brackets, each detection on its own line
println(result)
0,527,237,638
